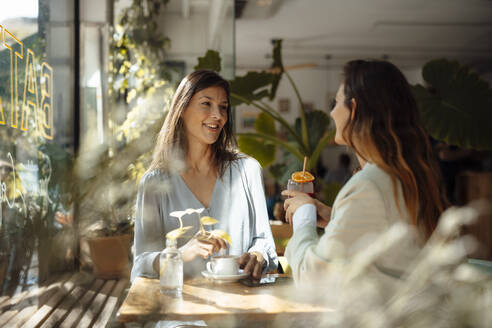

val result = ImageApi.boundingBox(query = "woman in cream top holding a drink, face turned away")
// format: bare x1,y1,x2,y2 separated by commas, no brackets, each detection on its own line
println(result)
283,60,448,286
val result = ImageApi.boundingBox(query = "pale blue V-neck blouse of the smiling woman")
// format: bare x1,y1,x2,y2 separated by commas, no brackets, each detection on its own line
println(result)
131,154,278,281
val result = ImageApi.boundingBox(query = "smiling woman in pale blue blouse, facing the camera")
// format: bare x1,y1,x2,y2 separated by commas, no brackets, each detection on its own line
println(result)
131,70,277,280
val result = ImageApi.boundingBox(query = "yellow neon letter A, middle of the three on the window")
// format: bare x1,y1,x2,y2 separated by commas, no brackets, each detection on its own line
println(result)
21,49,39,131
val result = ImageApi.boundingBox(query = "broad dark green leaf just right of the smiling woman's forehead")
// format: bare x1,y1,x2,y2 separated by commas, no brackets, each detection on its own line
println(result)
230,71,275,106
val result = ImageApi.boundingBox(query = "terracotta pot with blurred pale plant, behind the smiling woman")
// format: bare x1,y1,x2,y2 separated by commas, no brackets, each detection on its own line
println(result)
73,111,162,279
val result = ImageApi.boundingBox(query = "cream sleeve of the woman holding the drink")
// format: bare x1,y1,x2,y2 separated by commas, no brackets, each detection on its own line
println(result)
286,179,388,282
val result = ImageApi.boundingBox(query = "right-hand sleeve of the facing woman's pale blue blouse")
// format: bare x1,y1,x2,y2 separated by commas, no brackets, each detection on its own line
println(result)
246,159,278,272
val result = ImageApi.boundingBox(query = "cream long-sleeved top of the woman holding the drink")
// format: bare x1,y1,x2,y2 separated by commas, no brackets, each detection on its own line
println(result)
285,163,421,290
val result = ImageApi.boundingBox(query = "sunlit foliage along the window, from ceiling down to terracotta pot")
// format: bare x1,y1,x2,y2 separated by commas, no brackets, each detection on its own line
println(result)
84,0,177,235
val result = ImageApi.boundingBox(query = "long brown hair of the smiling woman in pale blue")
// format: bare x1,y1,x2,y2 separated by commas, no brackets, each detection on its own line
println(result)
148,70,239,177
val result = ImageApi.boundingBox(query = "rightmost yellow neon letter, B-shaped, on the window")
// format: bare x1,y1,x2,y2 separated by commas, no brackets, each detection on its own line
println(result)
38,62,55,140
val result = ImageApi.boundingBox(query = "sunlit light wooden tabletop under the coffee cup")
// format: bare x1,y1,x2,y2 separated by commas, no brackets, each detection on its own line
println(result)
117,274,333,327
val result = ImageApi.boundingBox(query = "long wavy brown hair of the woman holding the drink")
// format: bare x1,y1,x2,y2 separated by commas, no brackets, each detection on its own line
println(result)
342,60,449,240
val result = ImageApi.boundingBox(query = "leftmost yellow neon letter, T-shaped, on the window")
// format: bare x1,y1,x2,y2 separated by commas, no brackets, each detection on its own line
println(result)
3,29,24,128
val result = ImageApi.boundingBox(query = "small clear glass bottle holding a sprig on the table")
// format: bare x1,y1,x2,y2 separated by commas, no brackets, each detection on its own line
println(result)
159,239,183,296
